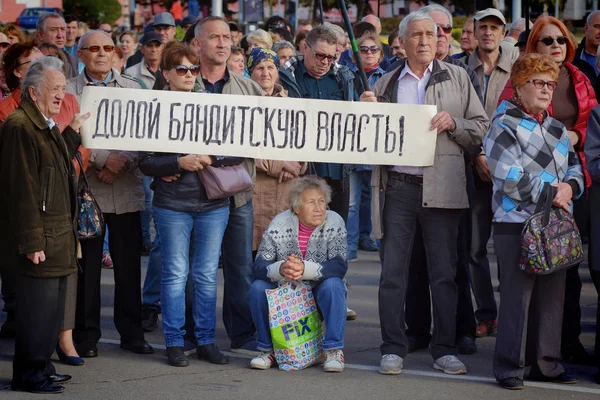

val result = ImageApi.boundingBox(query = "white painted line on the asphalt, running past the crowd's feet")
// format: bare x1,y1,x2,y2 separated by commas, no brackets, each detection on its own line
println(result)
100,339,600,394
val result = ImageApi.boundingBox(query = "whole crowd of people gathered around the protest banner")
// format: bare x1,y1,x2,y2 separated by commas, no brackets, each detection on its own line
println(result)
0,5,600,393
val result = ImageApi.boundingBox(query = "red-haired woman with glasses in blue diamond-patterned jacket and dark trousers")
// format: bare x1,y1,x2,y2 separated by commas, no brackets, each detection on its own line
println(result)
483,53,584,389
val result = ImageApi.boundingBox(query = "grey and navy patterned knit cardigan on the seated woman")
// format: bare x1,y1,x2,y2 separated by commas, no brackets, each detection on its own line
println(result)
252,210,348,282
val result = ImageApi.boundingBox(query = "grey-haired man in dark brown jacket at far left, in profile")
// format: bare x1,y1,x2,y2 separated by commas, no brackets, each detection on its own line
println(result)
0,57,89,393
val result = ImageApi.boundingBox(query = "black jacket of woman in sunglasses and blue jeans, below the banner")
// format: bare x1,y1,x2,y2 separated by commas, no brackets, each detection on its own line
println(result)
139,153,244,212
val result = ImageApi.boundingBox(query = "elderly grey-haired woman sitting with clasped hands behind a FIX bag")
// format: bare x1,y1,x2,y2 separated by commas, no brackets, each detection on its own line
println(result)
250,176,348,372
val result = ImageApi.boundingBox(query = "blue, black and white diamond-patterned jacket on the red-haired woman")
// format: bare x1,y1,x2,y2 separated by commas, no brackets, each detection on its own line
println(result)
483,100,585,222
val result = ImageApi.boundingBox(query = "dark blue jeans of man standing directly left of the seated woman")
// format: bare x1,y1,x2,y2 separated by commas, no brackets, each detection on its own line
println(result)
222,201,256,348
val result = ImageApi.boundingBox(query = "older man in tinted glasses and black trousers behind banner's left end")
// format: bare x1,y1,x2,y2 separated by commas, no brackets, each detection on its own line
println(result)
67,31,153,357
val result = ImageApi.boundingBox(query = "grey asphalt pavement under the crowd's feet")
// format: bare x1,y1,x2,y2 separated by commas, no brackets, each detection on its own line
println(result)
0,248,600,400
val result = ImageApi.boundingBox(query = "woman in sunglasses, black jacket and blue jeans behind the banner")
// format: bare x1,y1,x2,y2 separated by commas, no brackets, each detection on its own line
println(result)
139,41,243,367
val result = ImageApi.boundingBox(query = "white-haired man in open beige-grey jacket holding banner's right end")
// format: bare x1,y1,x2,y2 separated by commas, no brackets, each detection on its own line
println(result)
361,11,489,374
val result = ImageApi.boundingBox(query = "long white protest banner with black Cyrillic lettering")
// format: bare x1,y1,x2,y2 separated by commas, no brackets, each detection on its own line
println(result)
81,86,437,166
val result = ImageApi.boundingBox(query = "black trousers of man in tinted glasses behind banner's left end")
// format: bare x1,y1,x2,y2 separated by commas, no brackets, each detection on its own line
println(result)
73,211,144,349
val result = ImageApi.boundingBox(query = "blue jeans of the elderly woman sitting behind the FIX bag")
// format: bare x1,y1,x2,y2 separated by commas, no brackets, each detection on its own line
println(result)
250,278,346,351
